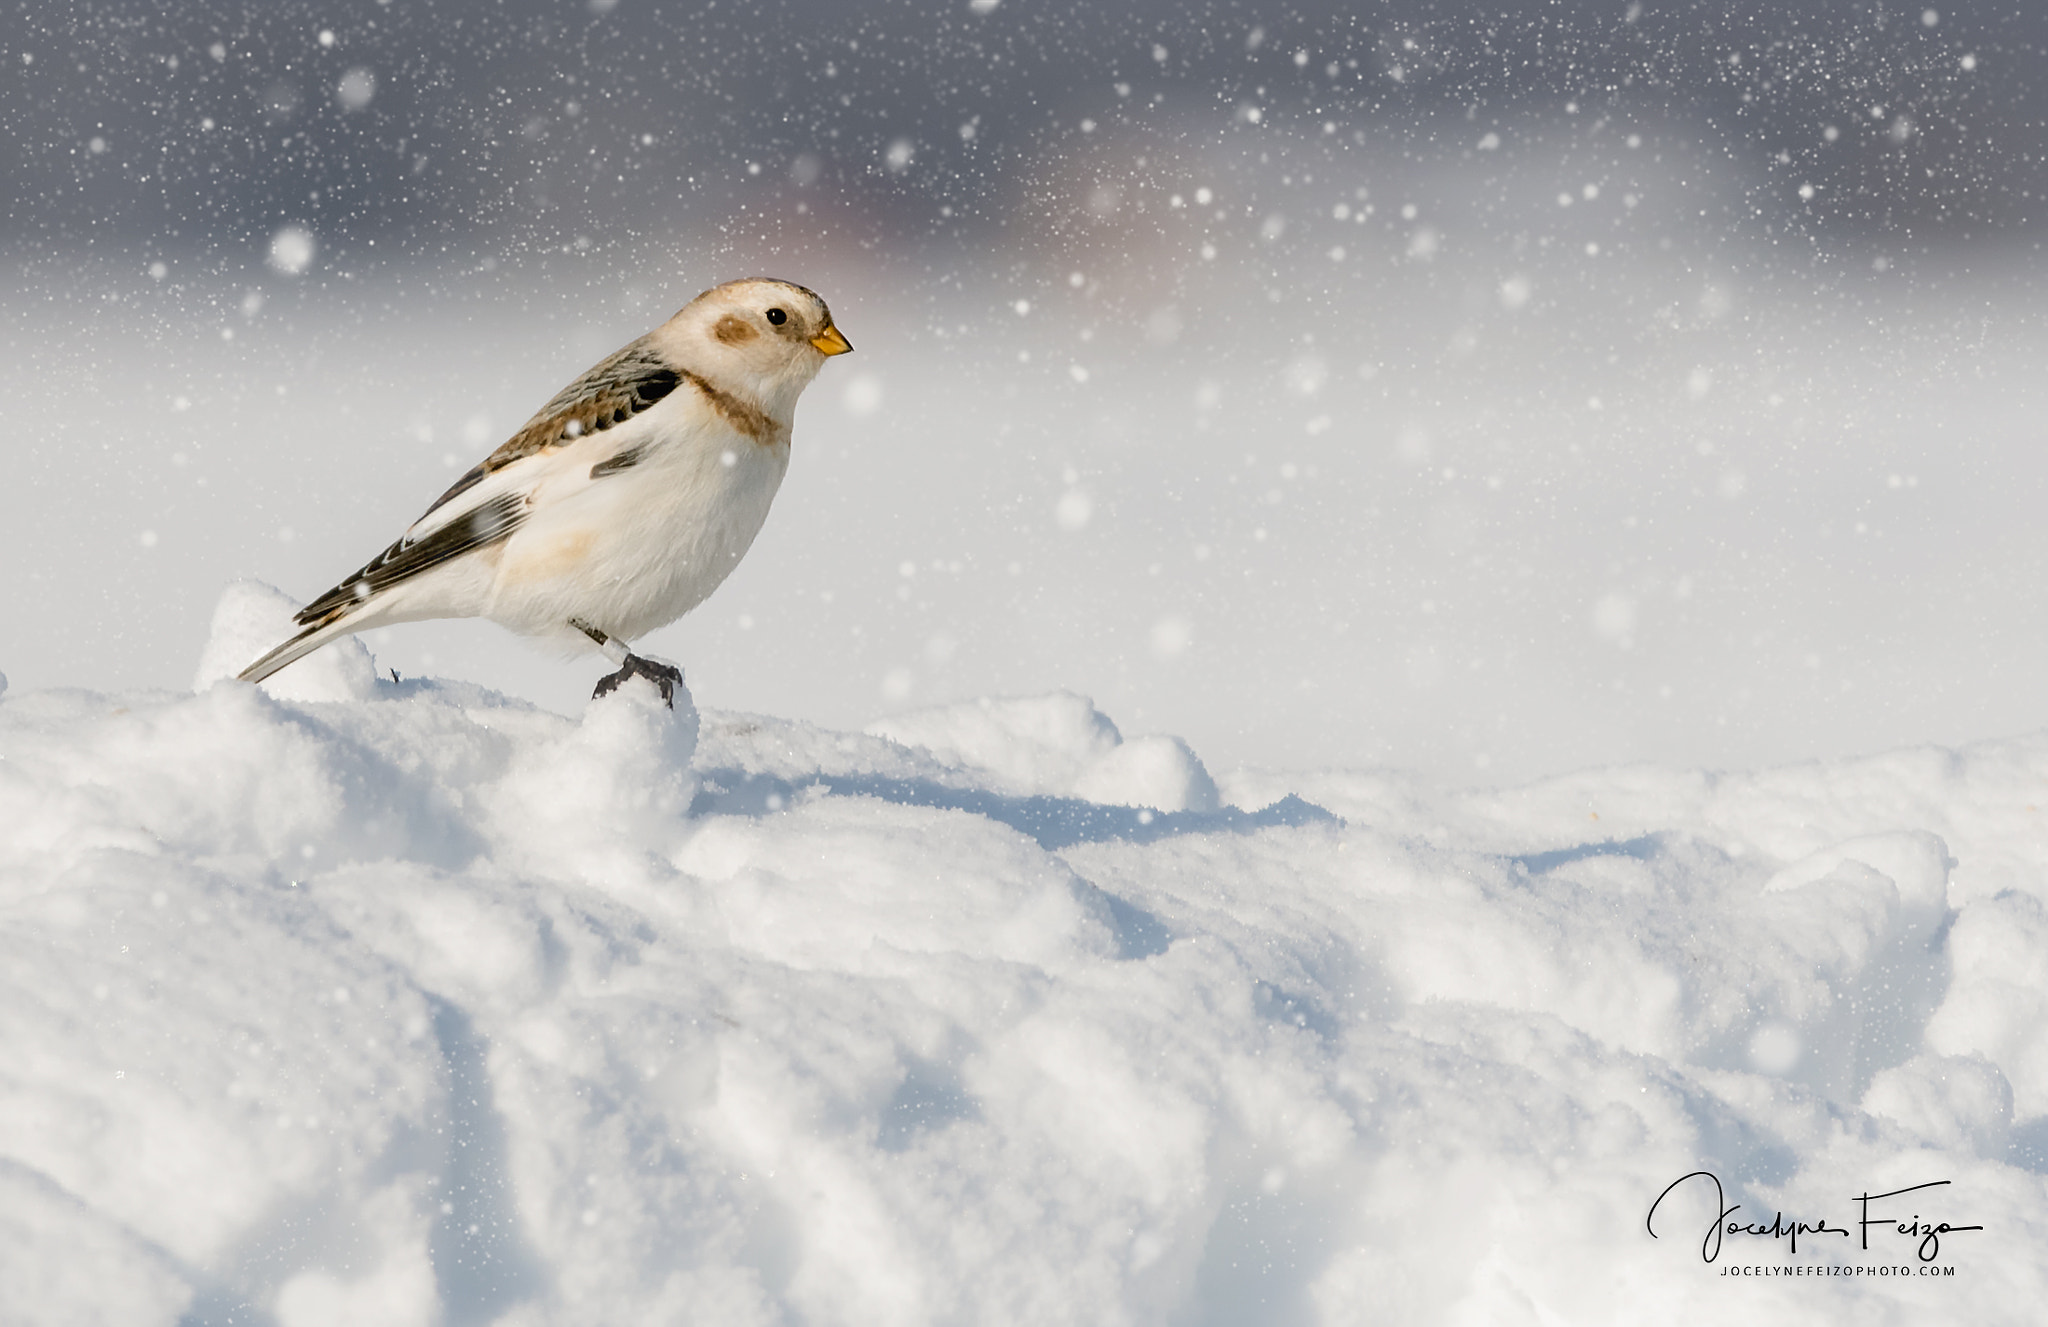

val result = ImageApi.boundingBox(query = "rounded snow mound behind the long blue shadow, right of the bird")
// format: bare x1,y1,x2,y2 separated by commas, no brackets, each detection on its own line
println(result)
868,692,1221,811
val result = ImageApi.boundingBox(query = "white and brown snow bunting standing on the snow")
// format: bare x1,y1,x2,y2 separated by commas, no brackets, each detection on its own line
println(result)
242,279,852,698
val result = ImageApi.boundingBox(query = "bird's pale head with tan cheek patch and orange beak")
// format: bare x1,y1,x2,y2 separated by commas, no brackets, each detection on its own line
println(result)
662,276,852,409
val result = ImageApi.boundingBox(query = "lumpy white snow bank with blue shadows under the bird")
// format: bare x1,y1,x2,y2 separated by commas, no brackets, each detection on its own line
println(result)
0,606,2048,1327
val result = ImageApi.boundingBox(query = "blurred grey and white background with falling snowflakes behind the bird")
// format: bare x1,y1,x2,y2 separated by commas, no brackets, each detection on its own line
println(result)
0,0,2048,780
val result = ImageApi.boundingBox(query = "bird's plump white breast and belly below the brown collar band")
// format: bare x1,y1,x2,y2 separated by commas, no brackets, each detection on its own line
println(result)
483,428,788,641
